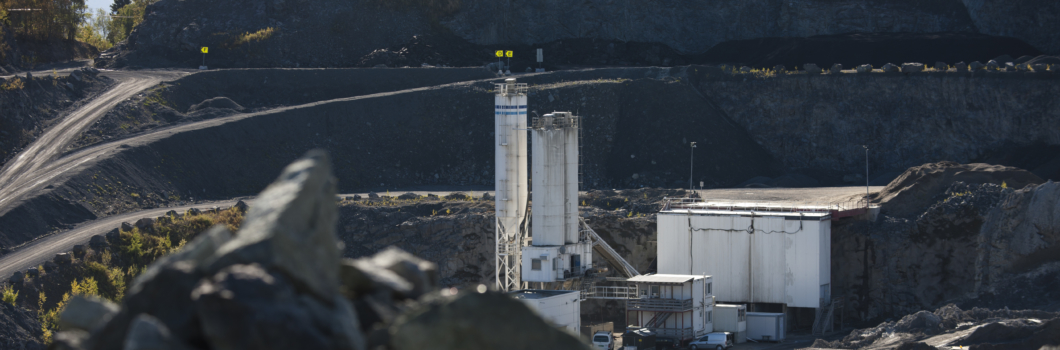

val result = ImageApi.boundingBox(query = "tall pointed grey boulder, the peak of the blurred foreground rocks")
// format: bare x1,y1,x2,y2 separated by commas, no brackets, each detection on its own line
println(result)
202,150,341,300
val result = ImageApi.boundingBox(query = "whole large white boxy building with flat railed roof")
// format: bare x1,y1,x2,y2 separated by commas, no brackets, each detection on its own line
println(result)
657,198,875,338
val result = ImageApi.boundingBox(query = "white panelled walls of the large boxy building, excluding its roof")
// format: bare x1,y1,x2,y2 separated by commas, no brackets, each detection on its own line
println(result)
658,213,831,308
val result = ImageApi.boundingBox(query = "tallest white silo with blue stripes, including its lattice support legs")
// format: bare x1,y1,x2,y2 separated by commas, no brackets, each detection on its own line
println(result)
494,78,529,291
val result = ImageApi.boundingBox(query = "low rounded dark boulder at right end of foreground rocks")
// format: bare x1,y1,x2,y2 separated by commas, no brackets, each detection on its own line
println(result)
390,292,589,350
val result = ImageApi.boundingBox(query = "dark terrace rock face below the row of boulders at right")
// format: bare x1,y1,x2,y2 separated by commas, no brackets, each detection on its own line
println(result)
689,68,1060,183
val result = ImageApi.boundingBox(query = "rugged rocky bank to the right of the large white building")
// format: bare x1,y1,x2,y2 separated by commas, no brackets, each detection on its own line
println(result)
832,181,1060,320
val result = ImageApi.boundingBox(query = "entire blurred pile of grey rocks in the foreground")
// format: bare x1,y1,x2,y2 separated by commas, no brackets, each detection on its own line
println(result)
51,151,587,350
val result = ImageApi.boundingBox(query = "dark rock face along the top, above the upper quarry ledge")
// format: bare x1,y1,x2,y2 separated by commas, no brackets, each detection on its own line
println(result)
98,0,1060,67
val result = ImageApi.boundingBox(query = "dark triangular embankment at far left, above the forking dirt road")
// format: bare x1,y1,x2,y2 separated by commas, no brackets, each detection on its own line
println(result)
0,71,114,163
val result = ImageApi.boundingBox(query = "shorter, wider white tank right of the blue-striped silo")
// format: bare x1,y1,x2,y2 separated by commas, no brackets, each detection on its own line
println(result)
531,111,580,246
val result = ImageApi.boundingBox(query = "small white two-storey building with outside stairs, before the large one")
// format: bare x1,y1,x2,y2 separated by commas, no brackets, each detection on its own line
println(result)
625,274,714,342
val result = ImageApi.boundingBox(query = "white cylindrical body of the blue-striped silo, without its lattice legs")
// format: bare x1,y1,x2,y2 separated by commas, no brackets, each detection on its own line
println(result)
494,78,529,238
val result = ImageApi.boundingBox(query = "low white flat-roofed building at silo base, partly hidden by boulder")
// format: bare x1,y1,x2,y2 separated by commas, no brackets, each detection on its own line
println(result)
508,290,582,334
